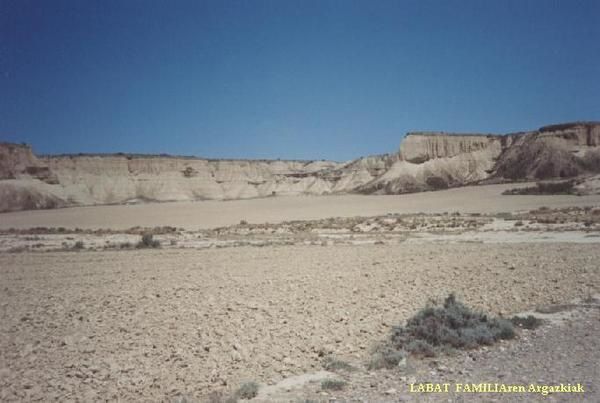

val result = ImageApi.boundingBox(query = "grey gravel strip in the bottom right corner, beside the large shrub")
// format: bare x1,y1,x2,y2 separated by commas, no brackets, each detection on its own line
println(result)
274,299,600,403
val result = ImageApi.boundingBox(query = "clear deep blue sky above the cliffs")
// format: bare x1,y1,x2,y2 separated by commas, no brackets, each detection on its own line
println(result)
0,0,600,160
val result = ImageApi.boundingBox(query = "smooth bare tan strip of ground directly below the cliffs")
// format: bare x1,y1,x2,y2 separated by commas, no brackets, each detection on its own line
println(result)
0,183,600,230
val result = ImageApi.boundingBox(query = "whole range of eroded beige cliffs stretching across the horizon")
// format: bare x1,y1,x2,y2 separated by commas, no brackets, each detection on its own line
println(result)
0,122,600,211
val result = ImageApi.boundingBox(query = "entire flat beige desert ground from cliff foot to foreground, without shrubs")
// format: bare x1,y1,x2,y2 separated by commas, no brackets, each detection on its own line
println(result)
0,184,600,402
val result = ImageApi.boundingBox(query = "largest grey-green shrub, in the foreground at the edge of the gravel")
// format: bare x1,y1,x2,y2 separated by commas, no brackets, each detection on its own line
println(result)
369,294,515,369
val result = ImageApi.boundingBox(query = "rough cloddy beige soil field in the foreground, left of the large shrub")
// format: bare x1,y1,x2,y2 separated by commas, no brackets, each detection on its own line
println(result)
0,243,600,401
